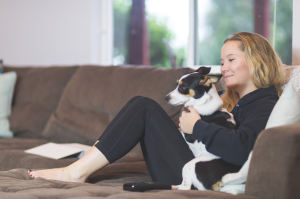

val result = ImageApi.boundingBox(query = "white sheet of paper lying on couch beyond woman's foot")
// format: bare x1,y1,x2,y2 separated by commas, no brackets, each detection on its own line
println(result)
25,142,84,160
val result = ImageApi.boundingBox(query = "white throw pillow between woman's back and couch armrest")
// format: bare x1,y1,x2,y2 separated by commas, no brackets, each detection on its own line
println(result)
266,84,300,129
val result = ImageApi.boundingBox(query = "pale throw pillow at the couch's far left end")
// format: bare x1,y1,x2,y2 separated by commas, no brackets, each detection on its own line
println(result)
0,72,17,138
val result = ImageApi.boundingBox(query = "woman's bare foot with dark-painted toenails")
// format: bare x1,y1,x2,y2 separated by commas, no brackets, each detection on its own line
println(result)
28,167,87,182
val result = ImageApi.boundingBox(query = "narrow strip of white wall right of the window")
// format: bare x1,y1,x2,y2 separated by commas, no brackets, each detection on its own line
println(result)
293,0,300,66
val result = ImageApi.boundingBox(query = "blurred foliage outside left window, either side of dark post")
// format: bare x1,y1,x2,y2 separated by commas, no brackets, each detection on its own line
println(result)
113,0,185,68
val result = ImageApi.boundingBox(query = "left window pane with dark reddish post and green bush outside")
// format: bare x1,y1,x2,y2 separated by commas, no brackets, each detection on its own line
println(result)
113,0,189,67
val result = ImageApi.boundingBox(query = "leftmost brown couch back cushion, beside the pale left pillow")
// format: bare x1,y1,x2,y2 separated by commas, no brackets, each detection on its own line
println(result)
4,67,78,138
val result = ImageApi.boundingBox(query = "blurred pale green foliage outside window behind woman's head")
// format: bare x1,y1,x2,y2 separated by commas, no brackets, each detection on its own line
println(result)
198,0,293,65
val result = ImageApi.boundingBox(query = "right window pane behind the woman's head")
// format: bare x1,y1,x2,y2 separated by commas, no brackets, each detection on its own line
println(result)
194,0,293,65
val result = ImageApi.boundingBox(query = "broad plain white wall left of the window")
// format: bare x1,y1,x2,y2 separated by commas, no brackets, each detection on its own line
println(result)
0,0,110,65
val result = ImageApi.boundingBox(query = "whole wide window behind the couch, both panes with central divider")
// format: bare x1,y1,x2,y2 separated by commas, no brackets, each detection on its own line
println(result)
113,0,293,69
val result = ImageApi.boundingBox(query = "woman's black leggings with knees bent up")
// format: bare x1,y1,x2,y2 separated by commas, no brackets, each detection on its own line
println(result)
95,96,194,185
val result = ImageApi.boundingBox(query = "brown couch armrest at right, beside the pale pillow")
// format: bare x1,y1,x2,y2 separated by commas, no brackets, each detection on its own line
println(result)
245,123,300,199
